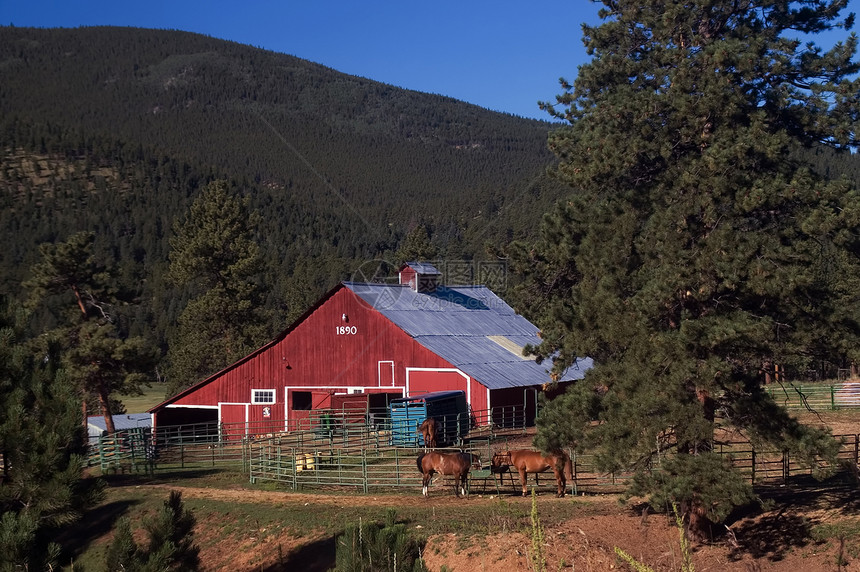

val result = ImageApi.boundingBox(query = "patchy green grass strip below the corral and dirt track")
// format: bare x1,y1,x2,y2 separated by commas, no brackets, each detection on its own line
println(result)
65,469,600,570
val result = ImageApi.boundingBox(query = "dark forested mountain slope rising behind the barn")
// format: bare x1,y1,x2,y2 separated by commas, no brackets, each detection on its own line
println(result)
0,27,564,348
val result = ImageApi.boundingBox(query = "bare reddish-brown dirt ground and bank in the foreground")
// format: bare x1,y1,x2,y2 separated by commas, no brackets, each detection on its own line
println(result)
122,415,860,572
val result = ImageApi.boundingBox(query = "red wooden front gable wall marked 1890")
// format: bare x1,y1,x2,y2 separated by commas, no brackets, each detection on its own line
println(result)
158,287,489,430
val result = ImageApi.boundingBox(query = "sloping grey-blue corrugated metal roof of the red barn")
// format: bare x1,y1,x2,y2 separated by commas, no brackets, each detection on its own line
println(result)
344,282,592,389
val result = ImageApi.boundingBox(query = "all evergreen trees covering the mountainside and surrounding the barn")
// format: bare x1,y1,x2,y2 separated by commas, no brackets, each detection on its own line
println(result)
5,6,860,570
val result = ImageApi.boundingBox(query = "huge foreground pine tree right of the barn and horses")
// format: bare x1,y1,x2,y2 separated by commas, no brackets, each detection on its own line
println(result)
512,0,860,537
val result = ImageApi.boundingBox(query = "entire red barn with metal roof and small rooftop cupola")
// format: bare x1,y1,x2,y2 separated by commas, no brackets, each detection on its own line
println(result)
150,263,591,433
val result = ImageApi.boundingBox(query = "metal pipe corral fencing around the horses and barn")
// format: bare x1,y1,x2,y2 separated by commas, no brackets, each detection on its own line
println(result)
90,404,860,494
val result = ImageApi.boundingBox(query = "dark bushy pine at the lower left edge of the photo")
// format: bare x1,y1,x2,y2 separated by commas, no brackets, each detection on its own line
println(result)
0,300,102,570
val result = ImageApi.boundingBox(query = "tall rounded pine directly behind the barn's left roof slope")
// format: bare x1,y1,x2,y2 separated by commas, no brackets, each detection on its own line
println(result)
168,181,269,392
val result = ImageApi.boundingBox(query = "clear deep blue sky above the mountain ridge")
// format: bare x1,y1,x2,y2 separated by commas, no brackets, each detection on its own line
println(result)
0,0,860,119
